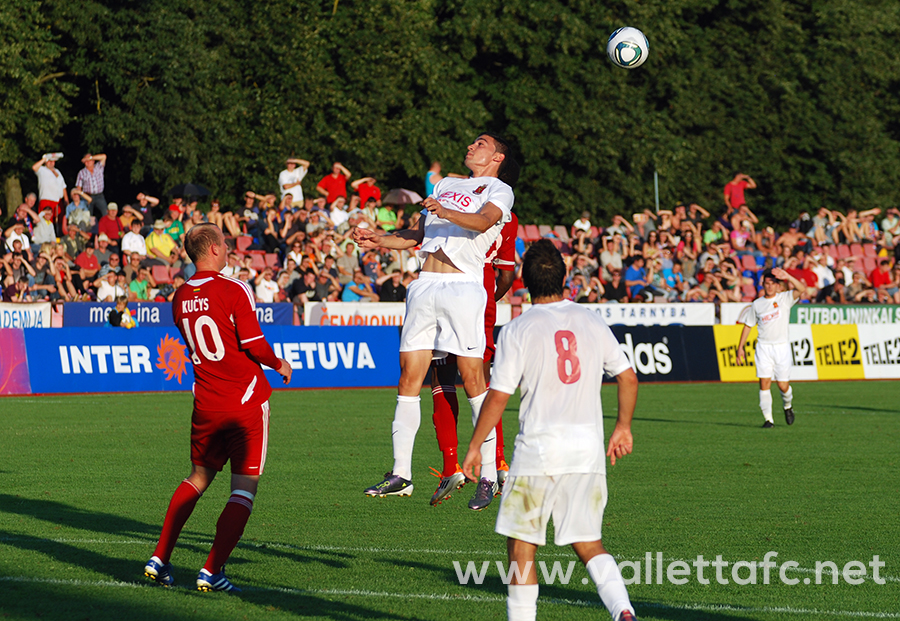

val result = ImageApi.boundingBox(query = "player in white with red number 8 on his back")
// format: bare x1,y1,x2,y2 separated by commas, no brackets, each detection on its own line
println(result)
463,239,638,621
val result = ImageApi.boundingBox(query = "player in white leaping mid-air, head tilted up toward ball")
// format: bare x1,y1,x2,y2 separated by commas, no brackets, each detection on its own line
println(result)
353,134,518,511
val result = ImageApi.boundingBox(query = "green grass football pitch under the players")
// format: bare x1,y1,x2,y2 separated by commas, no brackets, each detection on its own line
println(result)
0,382,900,621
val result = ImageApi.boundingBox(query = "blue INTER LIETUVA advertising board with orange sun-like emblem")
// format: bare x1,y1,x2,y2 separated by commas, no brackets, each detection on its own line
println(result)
20,326,400,394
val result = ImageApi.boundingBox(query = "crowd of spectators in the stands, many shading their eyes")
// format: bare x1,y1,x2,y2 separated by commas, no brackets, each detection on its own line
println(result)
0,153,900,310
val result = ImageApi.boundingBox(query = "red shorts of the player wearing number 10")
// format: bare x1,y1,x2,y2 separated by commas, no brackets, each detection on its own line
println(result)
191,401,269,475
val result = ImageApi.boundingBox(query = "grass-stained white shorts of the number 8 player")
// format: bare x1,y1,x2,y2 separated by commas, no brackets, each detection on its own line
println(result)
494,473,607,546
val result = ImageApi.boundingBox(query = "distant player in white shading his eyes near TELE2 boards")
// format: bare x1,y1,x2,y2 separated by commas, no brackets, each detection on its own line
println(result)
737,267,806,429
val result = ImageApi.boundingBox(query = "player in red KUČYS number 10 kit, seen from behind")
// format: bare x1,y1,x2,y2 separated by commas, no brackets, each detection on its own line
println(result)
144,224,291,591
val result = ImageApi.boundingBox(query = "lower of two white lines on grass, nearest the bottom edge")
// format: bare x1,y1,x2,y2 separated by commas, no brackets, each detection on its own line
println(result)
0,576,900,619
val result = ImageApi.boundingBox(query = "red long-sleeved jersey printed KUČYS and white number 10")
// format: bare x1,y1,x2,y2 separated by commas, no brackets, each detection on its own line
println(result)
172,272,280,412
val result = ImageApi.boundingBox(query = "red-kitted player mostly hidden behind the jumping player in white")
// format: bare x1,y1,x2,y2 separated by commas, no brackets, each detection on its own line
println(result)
431,213,519,505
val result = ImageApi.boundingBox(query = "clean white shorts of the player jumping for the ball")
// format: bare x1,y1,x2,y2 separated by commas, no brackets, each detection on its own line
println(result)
400,272,487,358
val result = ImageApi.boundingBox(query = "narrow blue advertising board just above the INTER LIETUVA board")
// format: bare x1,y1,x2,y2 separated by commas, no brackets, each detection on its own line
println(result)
63,302,294,328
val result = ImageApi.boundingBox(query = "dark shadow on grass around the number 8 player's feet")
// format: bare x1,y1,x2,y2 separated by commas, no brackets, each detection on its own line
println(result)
378,558,753,621
